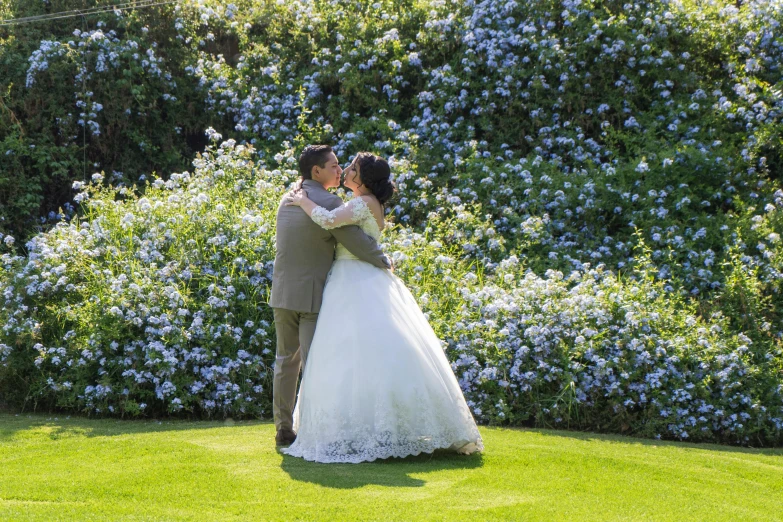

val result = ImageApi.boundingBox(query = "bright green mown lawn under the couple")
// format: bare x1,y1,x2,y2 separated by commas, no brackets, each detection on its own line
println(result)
0,414,783,521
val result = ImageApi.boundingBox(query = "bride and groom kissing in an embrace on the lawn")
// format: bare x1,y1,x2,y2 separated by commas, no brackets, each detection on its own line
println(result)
269,145,483,463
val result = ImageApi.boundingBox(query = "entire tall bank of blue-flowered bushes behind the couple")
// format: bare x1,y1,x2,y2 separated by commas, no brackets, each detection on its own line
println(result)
0,0,783,444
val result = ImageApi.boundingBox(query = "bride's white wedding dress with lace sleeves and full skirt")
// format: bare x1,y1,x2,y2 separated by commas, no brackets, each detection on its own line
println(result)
282,198,483,463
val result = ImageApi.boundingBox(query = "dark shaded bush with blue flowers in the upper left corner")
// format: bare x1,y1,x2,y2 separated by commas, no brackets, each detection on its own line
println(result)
0,0,211,239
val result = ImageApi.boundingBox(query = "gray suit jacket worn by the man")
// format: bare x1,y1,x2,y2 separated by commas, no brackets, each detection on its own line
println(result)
269,180,391,313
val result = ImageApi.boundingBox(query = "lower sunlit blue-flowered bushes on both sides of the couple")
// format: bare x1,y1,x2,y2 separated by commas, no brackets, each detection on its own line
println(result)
0,135,783,444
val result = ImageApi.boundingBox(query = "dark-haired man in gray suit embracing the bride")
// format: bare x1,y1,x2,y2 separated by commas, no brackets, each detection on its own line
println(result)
269,145,391,445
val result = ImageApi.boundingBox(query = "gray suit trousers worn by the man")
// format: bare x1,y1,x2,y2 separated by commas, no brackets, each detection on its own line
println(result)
272,308,318,430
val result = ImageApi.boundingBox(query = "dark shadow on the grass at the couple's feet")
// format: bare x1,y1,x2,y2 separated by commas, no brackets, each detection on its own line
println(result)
281,450,484,489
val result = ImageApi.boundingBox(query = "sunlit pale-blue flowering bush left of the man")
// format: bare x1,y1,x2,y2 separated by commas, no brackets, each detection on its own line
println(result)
2,137,282,415
